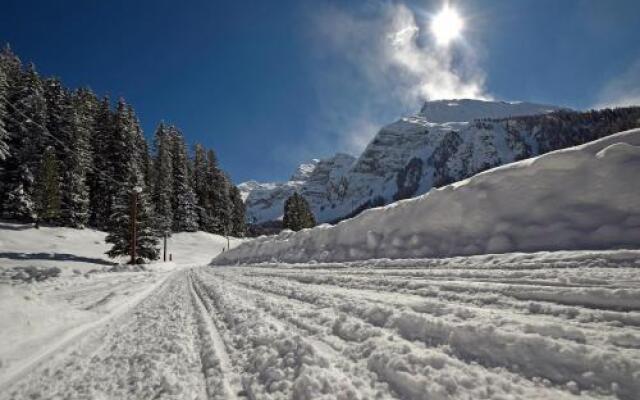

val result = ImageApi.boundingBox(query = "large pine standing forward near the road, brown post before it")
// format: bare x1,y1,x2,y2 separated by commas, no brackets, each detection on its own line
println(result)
106,99,159,262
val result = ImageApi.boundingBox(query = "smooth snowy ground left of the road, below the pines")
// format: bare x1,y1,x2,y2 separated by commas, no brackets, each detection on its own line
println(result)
0,222,239,392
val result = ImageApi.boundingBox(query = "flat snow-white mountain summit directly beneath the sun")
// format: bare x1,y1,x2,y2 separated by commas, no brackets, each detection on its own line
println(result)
420,99,562,123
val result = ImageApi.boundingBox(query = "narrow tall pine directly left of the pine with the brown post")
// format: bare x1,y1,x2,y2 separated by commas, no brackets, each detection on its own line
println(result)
87,96,114,229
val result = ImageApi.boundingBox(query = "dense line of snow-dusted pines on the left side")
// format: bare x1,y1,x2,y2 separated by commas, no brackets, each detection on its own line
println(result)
0,45,246,259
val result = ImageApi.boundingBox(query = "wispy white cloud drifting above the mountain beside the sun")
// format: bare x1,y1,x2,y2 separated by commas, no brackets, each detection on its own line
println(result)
304,1,489,154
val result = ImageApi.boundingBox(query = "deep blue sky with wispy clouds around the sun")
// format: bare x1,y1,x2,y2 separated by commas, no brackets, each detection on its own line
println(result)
0,0,640,183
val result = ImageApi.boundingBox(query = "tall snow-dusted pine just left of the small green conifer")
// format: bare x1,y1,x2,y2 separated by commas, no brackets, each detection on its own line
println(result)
2,64,46,220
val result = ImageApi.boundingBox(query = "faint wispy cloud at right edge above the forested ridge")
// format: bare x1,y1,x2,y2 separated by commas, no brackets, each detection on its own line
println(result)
594,59,640,108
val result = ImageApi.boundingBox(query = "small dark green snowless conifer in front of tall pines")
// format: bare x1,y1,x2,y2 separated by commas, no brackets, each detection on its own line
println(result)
35,147,60,223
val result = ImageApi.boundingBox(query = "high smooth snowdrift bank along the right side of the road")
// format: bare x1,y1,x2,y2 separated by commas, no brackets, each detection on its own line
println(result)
213,129,640,264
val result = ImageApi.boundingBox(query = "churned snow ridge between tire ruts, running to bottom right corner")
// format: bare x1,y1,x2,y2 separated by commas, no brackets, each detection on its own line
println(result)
206,262,640,399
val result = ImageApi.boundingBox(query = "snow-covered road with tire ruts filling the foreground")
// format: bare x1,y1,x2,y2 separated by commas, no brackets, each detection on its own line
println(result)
0,251,640,400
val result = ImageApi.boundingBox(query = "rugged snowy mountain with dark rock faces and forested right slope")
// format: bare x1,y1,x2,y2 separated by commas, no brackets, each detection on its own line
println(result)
240,99,637,227
